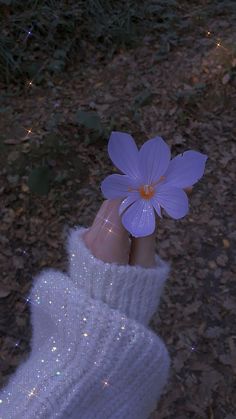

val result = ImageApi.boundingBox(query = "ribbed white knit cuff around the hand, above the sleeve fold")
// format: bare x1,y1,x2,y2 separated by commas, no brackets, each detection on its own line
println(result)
66,227,170,325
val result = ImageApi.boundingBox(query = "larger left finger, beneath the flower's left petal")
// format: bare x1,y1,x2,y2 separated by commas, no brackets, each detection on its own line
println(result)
83,199,130,265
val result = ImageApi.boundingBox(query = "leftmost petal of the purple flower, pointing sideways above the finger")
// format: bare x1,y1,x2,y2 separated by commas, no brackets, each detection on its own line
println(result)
101,174,139,199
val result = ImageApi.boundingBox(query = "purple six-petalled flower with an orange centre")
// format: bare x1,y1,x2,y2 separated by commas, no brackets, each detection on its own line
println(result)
101,131,208,237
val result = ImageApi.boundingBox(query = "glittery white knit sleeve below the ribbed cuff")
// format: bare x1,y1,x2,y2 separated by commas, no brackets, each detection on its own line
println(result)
0,269,170,419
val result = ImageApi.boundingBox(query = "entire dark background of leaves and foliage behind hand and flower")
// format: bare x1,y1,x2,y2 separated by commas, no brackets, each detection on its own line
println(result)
0,0,236,419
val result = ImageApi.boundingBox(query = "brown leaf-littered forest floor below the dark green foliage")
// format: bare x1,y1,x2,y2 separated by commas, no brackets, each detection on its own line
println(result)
0,3,236,419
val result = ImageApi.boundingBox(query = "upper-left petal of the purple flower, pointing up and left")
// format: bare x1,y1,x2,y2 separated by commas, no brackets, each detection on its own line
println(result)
108,131,140,178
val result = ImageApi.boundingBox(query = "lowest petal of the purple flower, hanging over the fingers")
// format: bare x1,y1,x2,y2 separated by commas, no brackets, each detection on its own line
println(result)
121,199,156,237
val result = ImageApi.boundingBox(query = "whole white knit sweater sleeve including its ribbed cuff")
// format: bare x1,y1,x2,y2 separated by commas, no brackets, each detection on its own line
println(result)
0,227,170,419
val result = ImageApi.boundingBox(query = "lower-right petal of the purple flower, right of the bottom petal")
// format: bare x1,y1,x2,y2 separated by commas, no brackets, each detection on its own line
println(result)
155,185,188,220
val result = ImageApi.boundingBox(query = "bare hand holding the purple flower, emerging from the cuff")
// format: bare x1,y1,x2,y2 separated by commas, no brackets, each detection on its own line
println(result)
83,188,192,268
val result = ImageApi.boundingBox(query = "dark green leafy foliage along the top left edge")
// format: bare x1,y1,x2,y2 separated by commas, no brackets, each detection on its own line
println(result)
0,0,183,83
